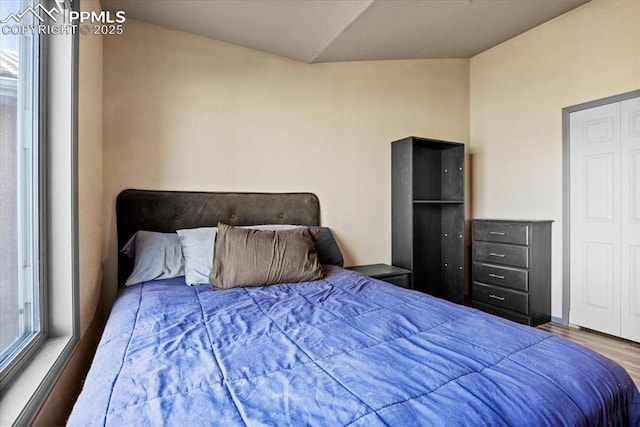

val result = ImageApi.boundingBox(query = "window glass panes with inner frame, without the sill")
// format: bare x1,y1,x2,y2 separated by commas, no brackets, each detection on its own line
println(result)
0,1,44,388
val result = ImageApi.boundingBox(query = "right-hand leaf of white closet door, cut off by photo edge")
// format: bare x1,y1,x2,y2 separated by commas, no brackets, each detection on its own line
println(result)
620,98,640,342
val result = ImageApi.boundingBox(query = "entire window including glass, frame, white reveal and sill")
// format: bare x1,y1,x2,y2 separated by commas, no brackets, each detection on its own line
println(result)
0,0,78,425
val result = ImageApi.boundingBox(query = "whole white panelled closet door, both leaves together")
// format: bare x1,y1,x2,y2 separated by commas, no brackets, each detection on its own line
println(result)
568,98,640,342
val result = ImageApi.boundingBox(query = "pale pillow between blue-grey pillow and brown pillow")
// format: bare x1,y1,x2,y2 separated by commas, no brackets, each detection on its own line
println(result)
177,227,218,286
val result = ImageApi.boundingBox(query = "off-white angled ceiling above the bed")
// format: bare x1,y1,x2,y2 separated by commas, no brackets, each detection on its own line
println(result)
102,0,590,63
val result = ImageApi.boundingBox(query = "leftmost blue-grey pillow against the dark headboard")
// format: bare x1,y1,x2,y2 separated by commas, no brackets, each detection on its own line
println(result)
120,230,184,286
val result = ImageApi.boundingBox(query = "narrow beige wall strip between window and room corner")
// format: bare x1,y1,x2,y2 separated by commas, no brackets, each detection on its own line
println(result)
34,0,104,426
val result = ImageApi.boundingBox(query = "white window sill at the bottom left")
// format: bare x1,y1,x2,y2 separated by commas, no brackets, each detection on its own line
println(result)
0,335,78,426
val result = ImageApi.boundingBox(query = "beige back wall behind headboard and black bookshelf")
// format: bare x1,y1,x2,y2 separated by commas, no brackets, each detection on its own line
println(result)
104,19,469,304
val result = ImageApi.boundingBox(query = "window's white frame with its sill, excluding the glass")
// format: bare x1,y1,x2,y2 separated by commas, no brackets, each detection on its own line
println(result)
0,0,80,425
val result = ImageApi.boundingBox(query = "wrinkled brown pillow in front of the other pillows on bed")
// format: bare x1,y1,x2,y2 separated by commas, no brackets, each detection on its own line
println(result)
209,223,324,289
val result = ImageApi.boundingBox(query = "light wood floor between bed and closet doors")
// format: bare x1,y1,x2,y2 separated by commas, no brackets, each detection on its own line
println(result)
539,323,640,389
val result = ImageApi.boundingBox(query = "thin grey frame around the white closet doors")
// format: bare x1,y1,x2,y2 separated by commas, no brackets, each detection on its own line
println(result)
559,89,640,325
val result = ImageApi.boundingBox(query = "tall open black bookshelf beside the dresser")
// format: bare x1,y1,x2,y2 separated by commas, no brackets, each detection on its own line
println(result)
391,137,464,304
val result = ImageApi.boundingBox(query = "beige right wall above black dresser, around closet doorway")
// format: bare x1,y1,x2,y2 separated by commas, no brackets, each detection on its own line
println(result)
470,0,640,317
